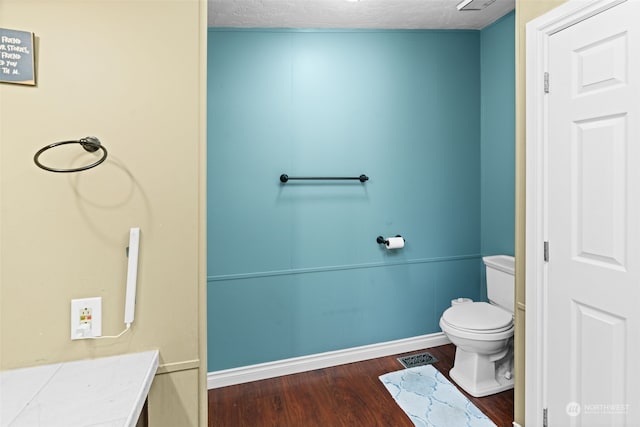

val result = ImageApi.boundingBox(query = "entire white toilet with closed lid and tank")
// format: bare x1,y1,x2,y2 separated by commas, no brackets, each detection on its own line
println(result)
440,255,515,397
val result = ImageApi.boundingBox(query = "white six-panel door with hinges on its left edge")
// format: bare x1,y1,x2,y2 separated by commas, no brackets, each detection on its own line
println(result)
544,0,640,427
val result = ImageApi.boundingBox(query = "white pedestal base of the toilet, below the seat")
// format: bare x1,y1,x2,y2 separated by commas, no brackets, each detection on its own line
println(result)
449,348,513,397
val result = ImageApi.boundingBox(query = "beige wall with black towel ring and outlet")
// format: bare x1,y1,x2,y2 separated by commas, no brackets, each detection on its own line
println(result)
0,0,207,427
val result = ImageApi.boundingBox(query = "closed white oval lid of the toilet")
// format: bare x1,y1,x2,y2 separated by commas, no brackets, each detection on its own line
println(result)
442,302,513,332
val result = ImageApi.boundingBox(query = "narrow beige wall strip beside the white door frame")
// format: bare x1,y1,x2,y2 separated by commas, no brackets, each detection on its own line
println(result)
514,0,565,426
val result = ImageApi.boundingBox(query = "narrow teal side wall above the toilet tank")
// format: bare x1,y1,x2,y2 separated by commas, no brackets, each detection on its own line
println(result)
480,12,516,255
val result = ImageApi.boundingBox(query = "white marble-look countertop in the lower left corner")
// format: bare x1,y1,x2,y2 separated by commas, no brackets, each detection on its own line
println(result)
0,350,159,427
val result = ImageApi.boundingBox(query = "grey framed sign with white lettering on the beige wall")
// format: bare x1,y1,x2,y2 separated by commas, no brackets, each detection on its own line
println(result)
0,28,36,86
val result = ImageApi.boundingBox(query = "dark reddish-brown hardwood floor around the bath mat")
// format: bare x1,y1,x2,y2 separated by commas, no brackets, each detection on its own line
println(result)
209,344,513,427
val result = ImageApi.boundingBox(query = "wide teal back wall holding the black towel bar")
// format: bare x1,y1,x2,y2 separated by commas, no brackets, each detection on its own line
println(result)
207,22,513,371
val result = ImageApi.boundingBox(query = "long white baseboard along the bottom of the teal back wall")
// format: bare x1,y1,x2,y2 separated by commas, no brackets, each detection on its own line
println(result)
207,332,450,390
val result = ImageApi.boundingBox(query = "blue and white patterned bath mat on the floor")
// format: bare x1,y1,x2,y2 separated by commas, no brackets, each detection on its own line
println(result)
380,365,495,427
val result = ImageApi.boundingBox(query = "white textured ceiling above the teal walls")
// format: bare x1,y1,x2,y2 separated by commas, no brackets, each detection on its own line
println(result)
208,0,515,30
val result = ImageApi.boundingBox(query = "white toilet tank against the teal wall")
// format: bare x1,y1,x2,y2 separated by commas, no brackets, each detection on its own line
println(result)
482,255,515,313
